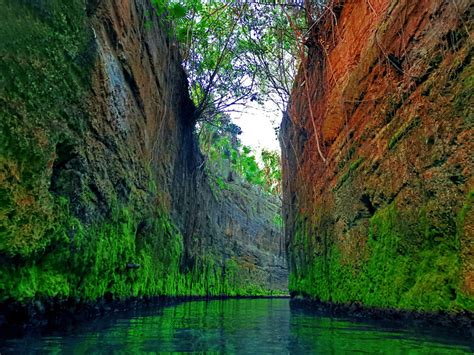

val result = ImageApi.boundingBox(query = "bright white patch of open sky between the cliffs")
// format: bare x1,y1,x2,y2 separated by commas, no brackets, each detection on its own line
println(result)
231,102,282,152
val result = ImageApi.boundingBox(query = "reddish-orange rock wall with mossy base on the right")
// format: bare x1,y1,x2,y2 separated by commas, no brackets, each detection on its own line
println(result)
281,0,474,311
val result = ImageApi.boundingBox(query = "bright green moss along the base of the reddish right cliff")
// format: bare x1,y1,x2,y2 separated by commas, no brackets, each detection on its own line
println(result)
290,203,474,311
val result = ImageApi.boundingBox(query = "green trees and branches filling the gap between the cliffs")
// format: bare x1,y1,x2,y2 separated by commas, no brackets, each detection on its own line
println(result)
149,0,292,194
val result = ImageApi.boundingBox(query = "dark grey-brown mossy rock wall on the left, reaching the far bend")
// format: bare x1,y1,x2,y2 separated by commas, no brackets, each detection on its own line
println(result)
0,0,286,302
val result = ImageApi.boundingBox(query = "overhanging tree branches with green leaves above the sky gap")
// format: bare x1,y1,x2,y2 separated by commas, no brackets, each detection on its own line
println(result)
153,0,304,120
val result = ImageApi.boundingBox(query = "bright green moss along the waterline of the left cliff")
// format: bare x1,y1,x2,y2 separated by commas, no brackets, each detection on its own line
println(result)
0,197,276,302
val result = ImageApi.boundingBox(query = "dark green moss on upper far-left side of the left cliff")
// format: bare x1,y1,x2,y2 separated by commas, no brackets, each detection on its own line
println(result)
0,0,94,257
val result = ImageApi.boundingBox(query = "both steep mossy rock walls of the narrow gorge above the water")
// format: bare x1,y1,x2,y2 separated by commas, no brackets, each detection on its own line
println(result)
0,0,474,344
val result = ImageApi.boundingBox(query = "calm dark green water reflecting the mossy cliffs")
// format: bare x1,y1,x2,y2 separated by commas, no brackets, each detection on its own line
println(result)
0,299,473,354
